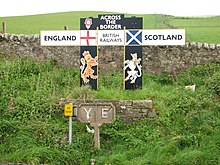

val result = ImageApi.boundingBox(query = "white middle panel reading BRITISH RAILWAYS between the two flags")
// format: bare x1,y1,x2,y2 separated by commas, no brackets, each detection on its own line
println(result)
98,30,125,46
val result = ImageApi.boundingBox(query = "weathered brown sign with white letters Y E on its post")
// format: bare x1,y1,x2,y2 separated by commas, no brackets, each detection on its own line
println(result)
77,103,115,149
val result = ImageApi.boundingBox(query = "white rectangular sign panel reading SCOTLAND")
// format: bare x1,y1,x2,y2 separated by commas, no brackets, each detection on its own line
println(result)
142,29,185,45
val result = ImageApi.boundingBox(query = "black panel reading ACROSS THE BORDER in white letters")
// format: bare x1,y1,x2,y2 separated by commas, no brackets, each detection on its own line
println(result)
98,14,125,30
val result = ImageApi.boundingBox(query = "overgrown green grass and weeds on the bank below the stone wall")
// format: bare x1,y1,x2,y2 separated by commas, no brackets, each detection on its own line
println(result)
0,56,220,165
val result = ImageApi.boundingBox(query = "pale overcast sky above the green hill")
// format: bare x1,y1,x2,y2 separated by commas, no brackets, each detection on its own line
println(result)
0,0,220,17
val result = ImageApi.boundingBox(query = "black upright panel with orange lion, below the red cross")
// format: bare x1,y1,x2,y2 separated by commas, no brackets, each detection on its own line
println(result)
80,46,98,90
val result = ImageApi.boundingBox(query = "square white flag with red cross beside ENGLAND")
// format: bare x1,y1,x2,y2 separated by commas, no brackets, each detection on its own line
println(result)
80,30,97,46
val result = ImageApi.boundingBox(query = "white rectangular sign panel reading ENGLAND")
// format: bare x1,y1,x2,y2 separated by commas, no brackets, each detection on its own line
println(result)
40,30,80,46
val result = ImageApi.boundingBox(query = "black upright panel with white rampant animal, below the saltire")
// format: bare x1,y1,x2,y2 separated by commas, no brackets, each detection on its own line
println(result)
124,46,142,89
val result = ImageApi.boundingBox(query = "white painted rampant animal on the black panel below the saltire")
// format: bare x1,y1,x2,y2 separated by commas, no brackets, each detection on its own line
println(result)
124,53,142,84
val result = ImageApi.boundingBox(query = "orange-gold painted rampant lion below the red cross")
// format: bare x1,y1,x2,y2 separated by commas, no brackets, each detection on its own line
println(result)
80,51,98,83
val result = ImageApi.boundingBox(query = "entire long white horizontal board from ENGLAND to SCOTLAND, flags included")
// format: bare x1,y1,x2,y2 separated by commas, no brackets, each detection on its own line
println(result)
41,29,185,46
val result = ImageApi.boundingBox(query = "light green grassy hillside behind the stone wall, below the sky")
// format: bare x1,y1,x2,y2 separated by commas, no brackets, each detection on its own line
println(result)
0,11,220,44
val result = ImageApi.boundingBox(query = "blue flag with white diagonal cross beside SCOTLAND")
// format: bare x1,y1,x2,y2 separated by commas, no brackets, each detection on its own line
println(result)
126,30,142,45
